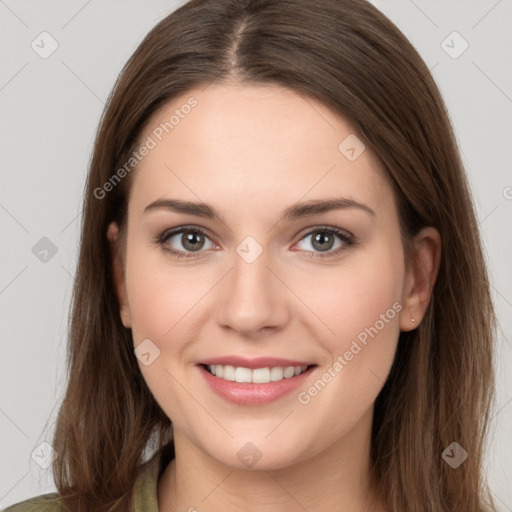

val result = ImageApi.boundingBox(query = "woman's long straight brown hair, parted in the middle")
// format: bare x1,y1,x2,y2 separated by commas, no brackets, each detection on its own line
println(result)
48,0,495,512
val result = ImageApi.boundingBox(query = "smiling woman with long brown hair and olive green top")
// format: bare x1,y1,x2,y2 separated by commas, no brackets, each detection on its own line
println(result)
1,0,494,512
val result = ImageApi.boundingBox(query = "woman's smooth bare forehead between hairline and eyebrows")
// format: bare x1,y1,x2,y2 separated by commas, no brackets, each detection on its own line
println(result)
130,84,391,220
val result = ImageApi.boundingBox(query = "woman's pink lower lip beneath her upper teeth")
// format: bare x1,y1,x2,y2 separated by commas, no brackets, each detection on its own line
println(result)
198,365,315,405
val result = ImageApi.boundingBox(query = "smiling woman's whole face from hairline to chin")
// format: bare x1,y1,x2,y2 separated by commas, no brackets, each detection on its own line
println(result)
109,84,418,469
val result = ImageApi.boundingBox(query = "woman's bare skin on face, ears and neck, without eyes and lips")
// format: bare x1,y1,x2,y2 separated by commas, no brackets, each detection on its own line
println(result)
107,83,441,512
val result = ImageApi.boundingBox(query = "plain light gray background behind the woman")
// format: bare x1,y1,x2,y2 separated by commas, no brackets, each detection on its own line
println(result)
0,0,512,511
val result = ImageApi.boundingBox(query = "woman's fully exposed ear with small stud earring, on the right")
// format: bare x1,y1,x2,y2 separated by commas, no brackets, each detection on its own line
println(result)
400,227,441,331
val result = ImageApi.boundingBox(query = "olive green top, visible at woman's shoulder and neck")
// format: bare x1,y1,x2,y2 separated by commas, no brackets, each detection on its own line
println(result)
0,443,174,512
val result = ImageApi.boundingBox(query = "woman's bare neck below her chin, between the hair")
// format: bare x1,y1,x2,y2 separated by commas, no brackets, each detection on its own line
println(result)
158,411,385,512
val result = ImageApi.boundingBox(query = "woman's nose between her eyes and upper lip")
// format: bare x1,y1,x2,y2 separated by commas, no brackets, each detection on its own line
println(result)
217,246,290,338
